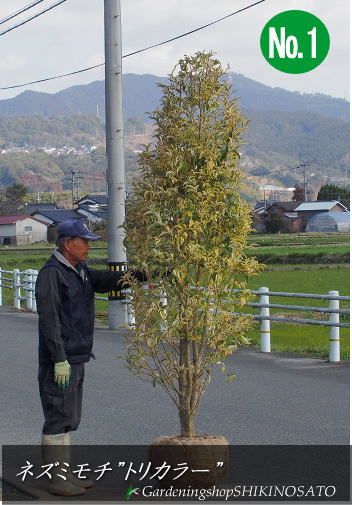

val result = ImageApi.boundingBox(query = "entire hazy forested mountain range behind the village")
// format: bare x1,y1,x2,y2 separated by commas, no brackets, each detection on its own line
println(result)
0,74,349,198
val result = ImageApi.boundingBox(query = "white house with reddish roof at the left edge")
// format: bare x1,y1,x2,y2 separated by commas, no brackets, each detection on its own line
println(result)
0,215,48,245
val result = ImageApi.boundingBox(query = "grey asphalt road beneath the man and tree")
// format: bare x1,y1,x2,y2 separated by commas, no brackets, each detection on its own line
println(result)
0,307,349,445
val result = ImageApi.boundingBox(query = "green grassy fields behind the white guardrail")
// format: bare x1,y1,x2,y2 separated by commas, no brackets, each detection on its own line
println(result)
0,234,349,359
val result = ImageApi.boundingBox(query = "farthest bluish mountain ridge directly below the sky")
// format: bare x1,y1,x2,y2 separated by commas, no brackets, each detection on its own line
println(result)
0,74,349,121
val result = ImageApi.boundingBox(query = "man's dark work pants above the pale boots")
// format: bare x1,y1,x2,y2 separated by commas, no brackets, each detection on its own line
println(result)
38,363,84,435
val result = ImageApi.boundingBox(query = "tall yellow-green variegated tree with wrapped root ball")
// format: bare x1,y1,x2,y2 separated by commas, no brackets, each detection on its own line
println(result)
124,52,260,485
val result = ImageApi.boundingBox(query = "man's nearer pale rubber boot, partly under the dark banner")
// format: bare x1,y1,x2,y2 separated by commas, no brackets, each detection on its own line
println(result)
42,433,86,496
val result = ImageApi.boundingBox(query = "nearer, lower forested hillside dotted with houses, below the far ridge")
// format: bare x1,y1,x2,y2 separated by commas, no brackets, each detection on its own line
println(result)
0,110,349,188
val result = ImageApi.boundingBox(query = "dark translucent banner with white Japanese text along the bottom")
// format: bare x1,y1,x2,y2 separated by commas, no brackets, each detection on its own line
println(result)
2,445,350,503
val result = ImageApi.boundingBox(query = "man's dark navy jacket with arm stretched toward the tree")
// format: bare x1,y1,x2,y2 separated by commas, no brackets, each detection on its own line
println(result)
36,255,127,363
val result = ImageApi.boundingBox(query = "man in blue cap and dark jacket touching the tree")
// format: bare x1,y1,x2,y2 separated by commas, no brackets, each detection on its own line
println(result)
35,219,146,496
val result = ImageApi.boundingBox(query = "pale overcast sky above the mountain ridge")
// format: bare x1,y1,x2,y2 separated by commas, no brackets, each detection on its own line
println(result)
0,0,350,99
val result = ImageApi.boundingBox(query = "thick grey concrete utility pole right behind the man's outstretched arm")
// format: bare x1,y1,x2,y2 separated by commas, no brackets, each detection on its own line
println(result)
104,0,128,329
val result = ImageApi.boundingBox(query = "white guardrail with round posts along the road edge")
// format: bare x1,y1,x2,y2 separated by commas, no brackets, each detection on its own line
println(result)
0,267,350,362
